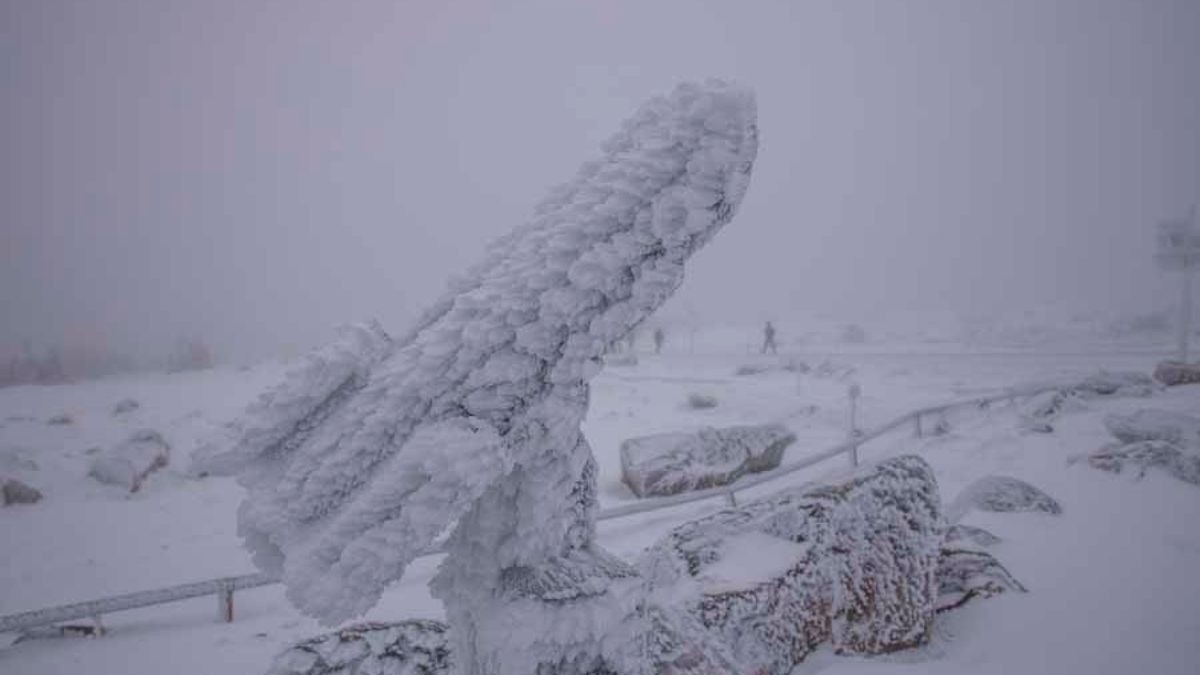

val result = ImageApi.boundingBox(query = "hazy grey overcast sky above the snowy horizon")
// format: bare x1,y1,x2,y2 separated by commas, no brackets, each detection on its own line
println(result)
0,0,1200,358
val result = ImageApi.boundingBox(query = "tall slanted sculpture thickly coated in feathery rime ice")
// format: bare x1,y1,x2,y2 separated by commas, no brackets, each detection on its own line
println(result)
199,82,757,675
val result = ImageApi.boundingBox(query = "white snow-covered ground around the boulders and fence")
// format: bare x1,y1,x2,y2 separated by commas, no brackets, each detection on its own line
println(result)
0,338,1200,675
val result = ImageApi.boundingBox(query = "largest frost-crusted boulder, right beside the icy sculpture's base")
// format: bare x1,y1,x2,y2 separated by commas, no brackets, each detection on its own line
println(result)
640,455,943,674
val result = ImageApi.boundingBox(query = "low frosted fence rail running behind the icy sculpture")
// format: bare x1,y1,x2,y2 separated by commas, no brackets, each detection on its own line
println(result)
0,383,1068,633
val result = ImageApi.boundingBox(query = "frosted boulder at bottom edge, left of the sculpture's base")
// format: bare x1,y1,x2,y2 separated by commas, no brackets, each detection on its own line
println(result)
266,620,454,675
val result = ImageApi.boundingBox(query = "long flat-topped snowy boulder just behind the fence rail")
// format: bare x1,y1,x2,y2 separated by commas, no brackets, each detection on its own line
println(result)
620,424,796,497
